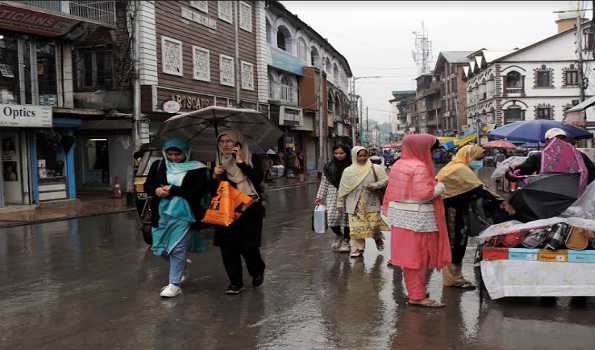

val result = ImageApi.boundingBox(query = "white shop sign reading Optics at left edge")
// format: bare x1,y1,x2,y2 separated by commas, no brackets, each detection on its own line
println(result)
0,104,52,128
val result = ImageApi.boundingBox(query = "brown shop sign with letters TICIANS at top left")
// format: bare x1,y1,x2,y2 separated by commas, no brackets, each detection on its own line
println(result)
0,4,77,37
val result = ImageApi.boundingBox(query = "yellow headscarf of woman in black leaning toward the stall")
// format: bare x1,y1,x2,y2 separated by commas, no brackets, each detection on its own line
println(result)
436,145,485,198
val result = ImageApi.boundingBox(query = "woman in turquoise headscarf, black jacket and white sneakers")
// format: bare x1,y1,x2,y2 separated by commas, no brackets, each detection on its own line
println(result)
145,138,208,298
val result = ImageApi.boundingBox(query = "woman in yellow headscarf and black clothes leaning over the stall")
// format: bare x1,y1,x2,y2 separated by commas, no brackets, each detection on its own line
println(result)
436,145,502,290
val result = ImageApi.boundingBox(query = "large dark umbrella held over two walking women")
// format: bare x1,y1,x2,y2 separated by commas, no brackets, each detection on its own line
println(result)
159,106,283,161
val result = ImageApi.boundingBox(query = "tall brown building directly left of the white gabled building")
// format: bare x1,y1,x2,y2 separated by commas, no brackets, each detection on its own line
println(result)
434,51,472,136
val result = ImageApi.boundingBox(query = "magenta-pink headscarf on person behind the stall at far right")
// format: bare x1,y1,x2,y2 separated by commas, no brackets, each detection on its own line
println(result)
540,138,589,193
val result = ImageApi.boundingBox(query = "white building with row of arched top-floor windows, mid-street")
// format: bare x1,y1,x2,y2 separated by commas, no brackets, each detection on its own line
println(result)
265,1,355,170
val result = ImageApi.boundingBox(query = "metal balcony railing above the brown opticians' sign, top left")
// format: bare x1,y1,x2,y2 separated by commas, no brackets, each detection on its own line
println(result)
15,0,116,26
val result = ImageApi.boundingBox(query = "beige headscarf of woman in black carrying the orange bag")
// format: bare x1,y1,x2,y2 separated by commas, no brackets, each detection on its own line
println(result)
217,130,258,196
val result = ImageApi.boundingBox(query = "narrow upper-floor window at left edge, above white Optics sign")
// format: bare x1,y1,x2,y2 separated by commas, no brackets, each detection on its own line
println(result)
0,32,20,104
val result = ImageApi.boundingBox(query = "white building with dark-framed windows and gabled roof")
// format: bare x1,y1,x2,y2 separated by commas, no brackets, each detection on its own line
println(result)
465,13,595,129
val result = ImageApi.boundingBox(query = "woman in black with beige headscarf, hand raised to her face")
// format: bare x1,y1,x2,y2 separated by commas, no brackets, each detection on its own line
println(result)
213,130,265,295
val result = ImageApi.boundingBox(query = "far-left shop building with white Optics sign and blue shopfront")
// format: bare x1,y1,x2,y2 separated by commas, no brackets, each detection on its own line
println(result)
0,0,124,207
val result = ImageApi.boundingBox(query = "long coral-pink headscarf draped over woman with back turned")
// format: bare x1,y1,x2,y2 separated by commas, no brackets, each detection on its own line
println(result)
382,134,451,268
